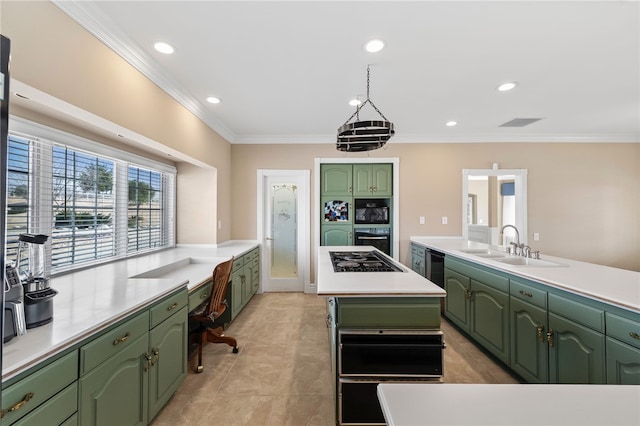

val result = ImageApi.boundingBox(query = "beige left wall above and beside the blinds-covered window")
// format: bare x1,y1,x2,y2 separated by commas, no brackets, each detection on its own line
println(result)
0,1,231,243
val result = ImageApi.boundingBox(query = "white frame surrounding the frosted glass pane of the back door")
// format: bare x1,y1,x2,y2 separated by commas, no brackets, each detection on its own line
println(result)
256,169,316,293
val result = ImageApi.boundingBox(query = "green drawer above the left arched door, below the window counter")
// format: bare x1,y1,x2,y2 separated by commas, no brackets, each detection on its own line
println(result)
80,311,149,375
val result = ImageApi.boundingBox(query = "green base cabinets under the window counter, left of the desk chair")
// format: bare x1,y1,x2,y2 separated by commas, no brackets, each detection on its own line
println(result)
2,288,188,426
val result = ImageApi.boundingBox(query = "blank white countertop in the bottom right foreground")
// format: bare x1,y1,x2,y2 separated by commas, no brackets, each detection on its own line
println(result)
378,383,640,426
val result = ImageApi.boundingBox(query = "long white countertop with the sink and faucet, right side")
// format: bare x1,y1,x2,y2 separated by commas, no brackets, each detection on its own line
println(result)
411,237,640,312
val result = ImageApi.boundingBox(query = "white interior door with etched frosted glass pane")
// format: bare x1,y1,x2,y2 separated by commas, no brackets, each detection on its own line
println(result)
258,170,310,292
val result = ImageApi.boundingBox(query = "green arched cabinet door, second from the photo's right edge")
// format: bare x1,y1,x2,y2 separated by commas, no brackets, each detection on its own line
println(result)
548,312,605,383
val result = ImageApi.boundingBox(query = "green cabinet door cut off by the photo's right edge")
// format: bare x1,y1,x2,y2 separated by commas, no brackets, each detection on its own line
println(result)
607,337,640,385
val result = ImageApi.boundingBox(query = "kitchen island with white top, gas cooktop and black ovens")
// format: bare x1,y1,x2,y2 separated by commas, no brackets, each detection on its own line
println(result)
317,246,446,424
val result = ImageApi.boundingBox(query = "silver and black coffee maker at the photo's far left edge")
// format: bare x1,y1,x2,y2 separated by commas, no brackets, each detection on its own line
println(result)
3,262,27,343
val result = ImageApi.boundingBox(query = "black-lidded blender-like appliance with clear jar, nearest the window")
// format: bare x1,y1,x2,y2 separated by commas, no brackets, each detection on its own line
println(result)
16,234,58,328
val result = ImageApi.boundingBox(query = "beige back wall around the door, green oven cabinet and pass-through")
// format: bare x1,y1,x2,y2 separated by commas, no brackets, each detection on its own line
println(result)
231,140,640,271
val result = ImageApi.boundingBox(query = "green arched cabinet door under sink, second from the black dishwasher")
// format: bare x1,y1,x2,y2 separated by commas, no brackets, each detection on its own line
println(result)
470,280,510,364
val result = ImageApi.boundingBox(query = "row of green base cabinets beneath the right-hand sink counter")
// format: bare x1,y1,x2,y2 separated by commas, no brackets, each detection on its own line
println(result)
445,256,640,384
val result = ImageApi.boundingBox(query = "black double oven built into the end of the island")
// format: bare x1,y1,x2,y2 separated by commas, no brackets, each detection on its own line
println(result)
338,330,444,425
